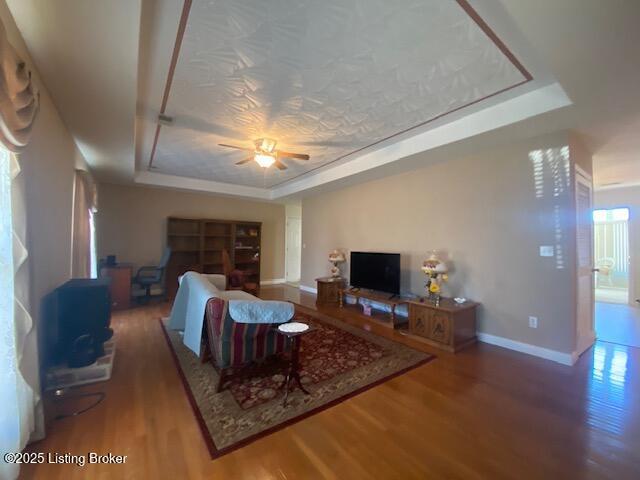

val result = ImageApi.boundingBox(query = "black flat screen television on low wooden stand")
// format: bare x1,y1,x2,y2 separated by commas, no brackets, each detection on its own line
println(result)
349,252,400,295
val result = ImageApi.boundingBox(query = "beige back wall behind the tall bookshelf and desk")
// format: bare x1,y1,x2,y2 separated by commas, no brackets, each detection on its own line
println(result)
97,184,285,280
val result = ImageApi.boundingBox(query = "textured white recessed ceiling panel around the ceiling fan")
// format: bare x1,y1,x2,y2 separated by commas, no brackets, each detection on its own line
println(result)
153,0,525,187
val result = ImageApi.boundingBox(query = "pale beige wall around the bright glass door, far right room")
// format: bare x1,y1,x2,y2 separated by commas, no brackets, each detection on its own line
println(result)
593,186,640,306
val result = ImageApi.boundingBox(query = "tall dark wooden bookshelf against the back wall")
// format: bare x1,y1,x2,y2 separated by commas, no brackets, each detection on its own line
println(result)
165,217,262,299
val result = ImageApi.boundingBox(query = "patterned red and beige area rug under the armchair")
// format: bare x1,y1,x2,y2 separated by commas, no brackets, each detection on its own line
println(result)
160,311,435,458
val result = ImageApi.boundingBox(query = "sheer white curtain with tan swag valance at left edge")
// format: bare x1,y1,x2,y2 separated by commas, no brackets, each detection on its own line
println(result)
0,15,44,480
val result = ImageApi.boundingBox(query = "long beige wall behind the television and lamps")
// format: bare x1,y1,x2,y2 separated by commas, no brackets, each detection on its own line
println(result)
302,133,575,353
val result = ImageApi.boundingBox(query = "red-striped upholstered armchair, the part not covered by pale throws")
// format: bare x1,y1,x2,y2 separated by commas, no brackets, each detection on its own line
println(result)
205,298,291,392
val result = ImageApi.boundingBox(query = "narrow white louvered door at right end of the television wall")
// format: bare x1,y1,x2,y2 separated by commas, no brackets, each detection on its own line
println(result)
576,167,595,355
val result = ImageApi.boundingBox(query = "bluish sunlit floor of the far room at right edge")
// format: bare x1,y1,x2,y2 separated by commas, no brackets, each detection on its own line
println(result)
595,302,640,348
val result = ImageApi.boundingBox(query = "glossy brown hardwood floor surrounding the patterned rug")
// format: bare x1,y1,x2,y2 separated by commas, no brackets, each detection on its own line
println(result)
22,286,640,480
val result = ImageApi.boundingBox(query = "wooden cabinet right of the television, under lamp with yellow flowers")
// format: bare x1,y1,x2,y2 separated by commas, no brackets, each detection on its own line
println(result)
409,298,478,352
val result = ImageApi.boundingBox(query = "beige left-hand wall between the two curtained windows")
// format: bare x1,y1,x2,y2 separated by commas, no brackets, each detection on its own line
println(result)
0,0,86,394
